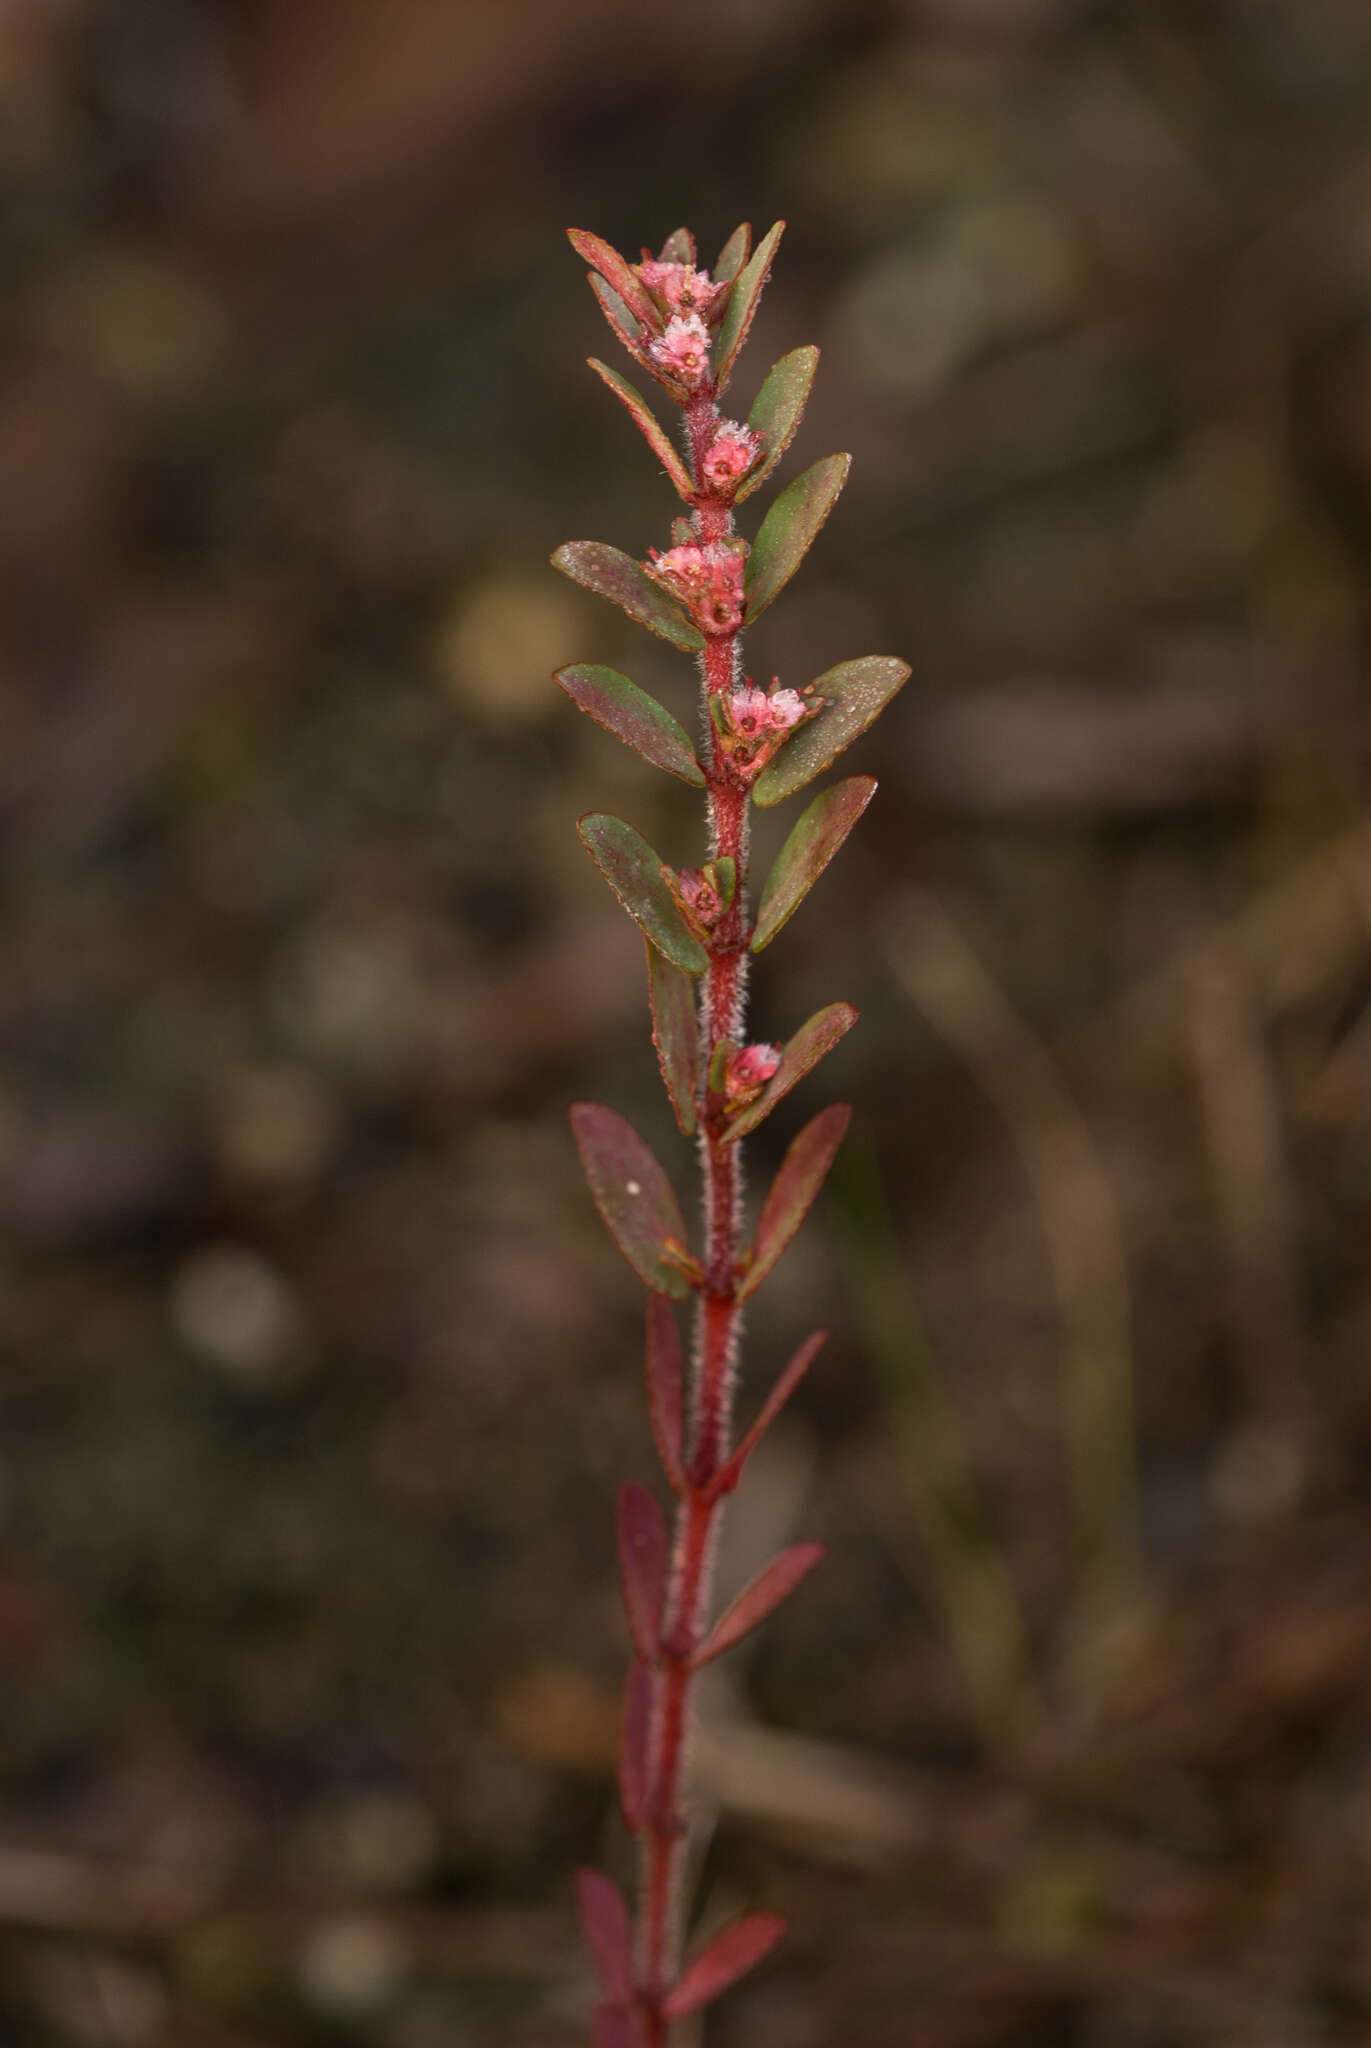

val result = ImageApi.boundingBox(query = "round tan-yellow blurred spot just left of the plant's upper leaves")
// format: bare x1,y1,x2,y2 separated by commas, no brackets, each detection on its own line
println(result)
434,569,584,723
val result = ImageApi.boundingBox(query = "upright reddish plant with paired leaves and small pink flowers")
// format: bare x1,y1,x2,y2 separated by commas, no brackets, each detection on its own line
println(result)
553,223,908,2048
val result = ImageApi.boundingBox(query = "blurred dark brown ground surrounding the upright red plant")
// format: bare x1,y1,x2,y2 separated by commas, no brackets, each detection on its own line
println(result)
0,0,1371,2048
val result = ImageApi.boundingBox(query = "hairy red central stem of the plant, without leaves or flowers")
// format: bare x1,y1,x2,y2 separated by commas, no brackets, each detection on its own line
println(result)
637,391,748,2048
